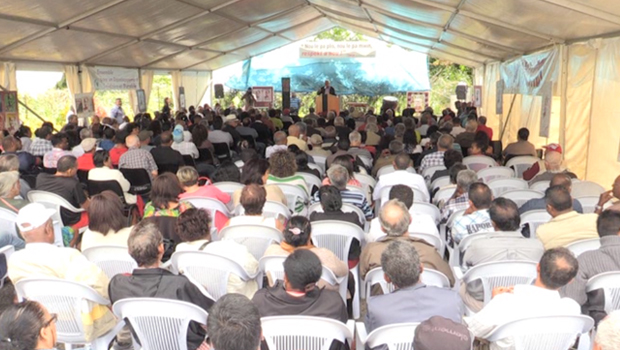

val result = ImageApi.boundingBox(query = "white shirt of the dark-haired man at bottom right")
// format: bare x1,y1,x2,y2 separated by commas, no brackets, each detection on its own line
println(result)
463,285,581,350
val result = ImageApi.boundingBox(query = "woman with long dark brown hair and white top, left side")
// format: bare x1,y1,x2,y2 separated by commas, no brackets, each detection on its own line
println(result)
80,191,131,251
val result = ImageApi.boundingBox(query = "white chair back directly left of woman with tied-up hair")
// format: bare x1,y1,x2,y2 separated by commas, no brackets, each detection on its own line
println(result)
220,225,282,260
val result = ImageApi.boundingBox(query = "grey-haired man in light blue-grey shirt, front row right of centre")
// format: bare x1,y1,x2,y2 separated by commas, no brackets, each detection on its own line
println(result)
365,241,464,332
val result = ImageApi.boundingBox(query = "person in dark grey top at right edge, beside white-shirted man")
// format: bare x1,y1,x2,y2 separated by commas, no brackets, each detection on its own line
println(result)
561,211,620,323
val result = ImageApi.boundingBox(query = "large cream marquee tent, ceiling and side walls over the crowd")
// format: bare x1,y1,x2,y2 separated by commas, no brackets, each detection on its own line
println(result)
0,0,620,184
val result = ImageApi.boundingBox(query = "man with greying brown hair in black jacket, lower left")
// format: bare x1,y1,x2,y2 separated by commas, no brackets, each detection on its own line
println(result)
109,221,213,349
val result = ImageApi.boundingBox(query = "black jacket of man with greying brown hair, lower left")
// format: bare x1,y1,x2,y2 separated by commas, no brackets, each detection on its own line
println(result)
108,268,214,350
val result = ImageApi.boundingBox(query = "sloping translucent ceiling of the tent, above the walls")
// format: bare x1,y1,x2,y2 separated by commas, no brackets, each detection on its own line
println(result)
0,0,620,70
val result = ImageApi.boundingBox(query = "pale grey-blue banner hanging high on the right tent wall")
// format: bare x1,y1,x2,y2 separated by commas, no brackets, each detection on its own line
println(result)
500,49,560,96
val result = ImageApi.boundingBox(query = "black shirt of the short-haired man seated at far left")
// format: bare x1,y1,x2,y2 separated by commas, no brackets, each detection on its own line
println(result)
35,173,86,226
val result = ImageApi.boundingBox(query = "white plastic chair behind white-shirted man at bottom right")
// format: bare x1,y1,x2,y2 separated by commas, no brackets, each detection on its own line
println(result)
486,315,594,350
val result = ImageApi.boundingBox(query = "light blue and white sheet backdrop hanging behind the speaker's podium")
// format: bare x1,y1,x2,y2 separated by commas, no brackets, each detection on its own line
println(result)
226,40,430,96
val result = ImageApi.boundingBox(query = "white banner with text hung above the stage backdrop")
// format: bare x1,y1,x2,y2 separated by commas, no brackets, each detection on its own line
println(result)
299,40,377,58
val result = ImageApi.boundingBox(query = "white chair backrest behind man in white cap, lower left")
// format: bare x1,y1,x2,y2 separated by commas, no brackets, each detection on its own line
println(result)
15,278,110,344
